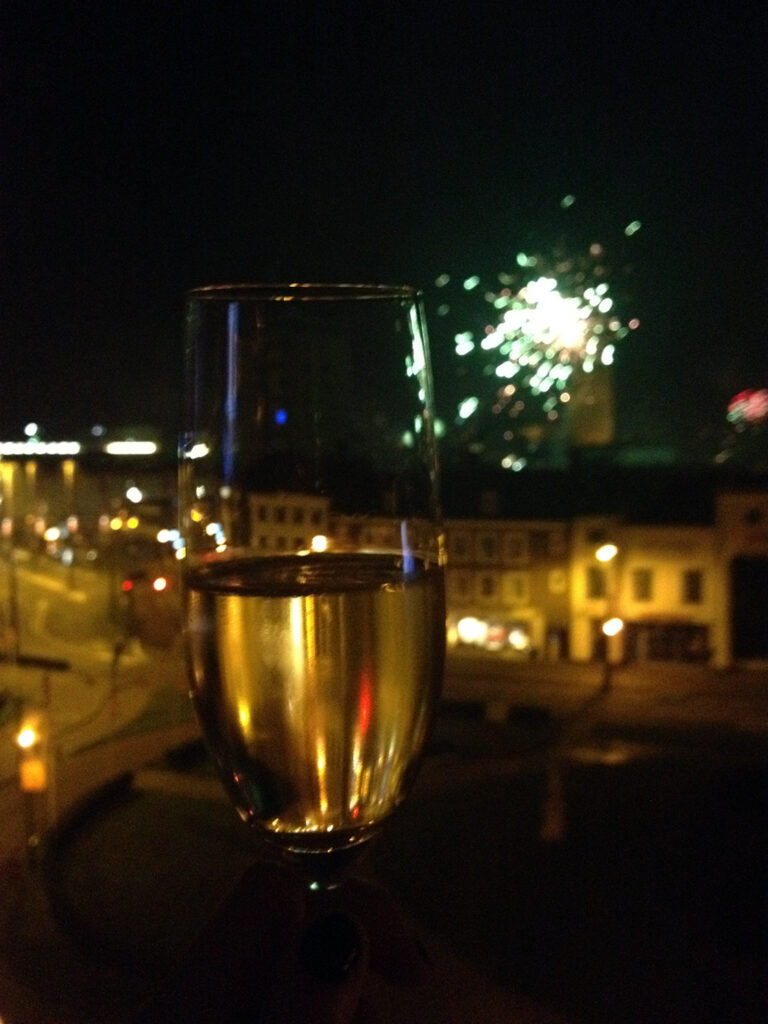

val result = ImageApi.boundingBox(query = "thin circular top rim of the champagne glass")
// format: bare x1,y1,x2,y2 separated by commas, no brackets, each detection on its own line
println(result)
186,282,422,302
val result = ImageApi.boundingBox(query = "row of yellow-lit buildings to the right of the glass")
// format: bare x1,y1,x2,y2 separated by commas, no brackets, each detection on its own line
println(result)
446,492,768,668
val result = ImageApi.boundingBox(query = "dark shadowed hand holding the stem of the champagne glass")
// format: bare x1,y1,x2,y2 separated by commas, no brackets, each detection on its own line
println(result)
140,864,431,1024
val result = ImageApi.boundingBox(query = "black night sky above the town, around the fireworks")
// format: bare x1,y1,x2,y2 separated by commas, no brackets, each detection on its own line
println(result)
0,0,768,452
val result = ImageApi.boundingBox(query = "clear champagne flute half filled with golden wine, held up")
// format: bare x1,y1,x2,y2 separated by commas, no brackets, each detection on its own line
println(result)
180,284,445,888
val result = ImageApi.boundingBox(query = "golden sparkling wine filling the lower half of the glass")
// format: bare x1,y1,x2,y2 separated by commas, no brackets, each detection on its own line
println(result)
187,555,444,852
